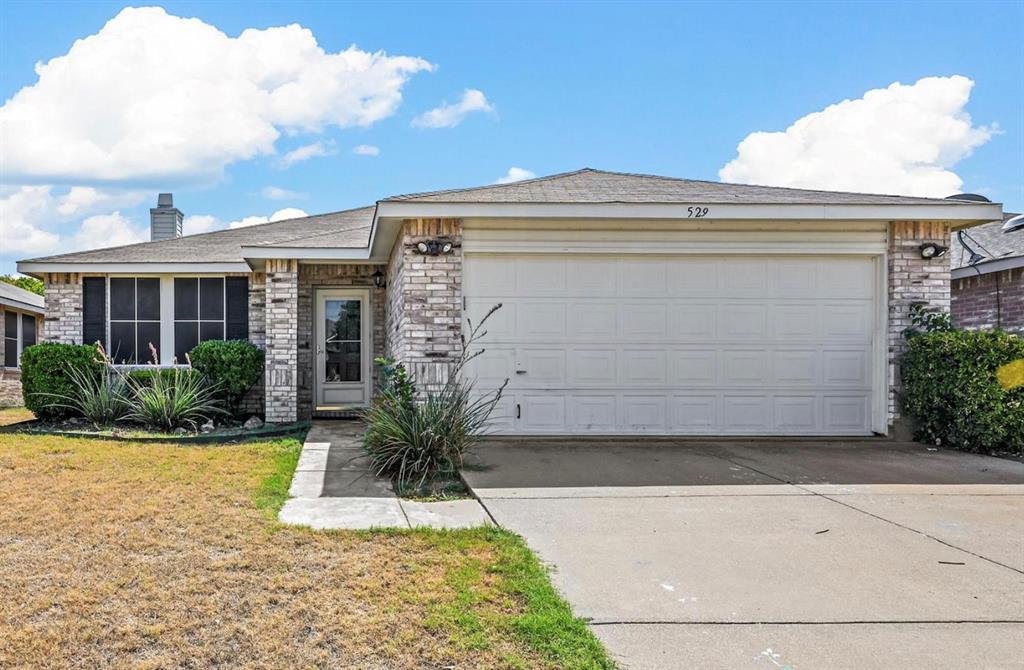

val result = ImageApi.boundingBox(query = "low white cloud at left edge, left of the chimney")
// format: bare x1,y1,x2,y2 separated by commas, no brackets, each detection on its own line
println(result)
0,185,145,255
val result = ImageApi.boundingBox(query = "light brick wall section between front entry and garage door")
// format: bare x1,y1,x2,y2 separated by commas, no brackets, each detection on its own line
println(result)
386,219,462,388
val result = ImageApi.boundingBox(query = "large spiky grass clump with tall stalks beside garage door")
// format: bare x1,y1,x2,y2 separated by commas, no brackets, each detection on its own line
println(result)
364,304,508,490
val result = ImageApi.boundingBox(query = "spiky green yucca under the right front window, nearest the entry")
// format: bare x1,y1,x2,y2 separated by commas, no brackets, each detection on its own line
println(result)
126,352,226,431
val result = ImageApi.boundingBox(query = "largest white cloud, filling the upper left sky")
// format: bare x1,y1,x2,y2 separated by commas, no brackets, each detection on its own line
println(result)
0,7,432,183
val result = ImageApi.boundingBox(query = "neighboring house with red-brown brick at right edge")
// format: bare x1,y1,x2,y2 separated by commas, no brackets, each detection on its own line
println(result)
949,214,1024,334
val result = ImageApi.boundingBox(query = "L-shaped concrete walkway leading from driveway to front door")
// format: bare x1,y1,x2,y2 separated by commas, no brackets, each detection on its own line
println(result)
279,421,490,530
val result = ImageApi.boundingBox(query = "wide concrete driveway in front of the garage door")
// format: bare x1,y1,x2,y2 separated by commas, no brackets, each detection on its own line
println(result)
464,439,1024,670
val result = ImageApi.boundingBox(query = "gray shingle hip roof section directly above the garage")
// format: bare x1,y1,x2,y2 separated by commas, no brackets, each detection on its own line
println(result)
384,168,983,205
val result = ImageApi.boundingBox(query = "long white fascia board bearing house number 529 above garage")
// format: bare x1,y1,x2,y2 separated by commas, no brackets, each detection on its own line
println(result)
377,202,1002,224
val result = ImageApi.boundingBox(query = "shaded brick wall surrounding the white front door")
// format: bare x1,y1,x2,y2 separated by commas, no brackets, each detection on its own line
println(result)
297,264,387,419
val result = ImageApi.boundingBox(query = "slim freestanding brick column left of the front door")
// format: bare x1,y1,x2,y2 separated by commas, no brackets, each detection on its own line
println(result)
264,259,299,423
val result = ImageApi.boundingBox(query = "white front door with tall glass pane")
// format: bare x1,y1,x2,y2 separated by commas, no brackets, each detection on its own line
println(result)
313,289,373,410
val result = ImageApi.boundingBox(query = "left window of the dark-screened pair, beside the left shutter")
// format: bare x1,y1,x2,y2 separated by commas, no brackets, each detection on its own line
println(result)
109,277,160,364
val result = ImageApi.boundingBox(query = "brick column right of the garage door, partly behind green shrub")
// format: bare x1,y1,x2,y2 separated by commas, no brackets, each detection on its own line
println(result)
889,221,949,423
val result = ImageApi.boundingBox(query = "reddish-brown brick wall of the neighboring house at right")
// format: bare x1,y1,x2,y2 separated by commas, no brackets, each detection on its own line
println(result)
951,267,1024,335
